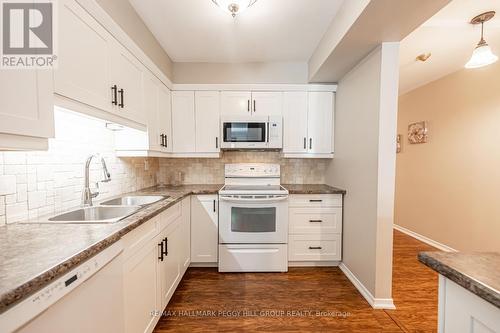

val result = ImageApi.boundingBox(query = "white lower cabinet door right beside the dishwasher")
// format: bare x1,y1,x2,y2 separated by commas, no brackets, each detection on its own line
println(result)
123,241,159,333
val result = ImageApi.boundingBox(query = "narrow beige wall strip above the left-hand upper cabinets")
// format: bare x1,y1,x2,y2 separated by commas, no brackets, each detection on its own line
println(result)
97,0,173,81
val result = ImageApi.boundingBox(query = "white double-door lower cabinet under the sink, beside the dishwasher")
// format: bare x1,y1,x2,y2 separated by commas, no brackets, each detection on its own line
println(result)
123,197,190,333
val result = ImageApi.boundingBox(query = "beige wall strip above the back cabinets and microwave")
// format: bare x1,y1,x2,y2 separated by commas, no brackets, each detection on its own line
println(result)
174,62,307,84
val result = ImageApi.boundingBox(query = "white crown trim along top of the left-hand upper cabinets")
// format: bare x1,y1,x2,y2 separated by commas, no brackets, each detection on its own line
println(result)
76,0,172,89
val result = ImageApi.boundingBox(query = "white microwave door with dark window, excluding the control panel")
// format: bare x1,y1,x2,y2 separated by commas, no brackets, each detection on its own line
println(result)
221,119,269,149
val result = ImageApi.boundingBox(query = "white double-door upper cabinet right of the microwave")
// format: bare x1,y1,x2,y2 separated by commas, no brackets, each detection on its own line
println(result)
283,92,334,157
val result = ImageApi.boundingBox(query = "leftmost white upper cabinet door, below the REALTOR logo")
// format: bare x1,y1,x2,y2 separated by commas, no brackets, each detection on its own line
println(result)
0,69,54,138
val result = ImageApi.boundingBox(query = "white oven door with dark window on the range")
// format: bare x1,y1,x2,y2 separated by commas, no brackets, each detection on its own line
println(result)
219,195,288,244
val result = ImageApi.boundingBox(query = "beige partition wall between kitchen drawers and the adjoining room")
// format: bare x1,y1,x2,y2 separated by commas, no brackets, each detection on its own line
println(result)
326,43,399,304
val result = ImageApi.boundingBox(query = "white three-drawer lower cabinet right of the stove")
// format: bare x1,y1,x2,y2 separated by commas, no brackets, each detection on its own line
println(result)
288,194,342,262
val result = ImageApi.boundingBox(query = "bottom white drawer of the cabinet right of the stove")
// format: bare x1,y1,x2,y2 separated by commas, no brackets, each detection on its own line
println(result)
288,234,342,261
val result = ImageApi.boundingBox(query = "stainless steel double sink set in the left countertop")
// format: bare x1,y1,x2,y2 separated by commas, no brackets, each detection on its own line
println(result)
37,195,170,224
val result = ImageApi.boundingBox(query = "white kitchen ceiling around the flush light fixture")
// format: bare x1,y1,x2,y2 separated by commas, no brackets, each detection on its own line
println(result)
129,0,344,63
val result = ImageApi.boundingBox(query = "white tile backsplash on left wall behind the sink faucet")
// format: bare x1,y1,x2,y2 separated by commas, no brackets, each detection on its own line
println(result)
0,109,158,224
